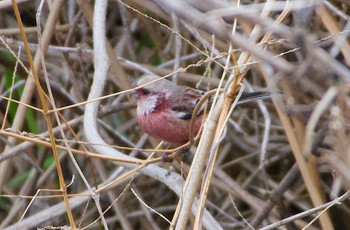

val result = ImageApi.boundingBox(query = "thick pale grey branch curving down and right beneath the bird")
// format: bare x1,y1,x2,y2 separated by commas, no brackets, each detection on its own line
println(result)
84,1,221,229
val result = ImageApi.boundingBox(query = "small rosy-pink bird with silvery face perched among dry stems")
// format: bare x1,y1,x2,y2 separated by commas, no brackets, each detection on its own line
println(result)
131,75,270,145
